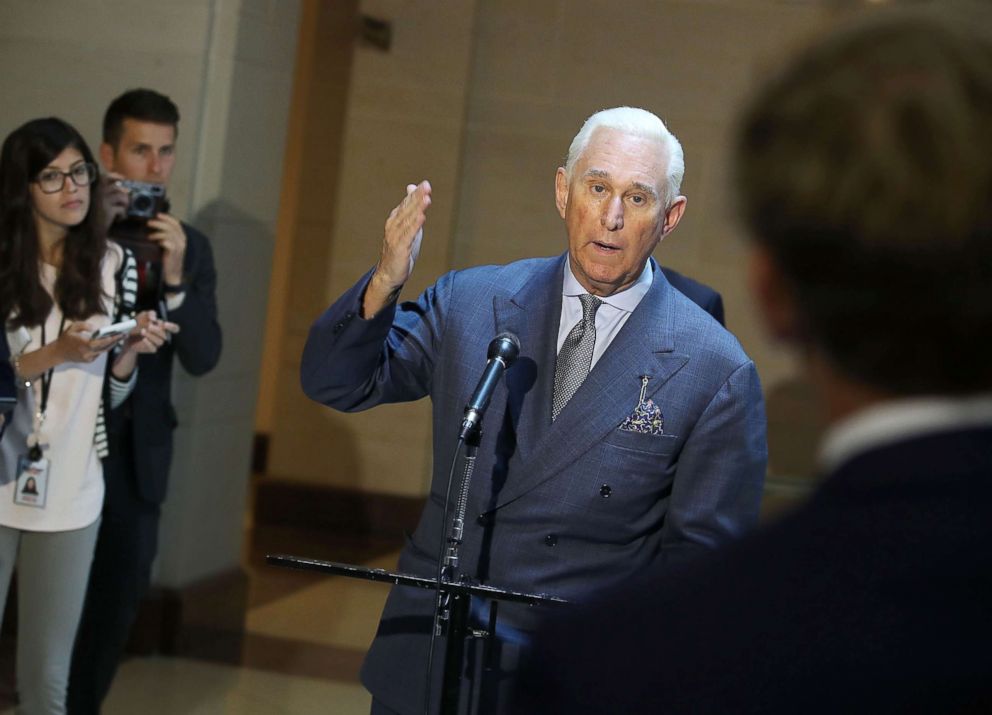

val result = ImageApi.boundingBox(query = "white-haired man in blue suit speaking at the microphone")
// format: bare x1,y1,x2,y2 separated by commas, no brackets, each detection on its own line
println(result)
301,107,766,714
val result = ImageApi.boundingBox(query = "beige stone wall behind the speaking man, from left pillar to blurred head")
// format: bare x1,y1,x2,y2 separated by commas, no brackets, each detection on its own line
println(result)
270,0,824,494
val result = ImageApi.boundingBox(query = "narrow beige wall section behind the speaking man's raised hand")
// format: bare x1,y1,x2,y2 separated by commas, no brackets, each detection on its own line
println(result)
269,0,474,494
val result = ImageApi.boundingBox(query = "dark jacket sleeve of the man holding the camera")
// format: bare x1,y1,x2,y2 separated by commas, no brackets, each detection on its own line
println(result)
169,224,222,375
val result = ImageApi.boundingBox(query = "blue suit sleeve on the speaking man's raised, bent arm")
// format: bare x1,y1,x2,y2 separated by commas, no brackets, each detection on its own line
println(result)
300,271,452,412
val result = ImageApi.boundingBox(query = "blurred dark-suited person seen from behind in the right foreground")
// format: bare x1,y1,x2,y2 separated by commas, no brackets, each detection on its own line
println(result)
520,4,992,713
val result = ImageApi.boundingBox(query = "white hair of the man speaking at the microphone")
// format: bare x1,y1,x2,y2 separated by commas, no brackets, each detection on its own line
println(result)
565,107,685,208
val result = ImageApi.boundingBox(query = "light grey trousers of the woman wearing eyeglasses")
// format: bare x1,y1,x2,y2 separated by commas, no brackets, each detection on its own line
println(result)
0,519,100,715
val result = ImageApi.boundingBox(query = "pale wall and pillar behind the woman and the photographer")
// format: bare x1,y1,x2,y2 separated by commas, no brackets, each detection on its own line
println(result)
0,0,299,586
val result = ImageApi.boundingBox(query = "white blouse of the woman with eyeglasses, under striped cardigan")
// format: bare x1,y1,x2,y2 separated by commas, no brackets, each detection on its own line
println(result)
0,244,123,531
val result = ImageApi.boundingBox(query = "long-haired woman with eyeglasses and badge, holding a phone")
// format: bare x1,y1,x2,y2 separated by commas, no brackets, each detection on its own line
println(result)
0,118,169,715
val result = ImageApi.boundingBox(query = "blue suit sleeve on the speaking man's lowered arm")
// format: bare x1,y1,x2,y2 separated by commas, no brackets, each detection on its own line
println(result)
661,361,768,564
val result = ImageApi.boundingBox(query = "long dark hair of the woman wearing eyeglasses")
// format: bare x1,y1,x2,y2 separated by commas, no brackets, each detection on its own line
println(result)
0,117,107,328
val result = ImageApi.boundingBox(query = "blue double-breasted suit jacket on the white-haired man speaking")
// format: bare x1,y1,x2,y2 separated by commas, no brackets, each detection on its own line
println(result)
301,255,766,712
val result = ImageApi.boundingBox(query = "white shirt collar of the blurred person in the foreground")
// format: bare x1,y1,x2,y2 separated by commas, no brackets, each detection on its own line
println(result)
819,394,992,473
